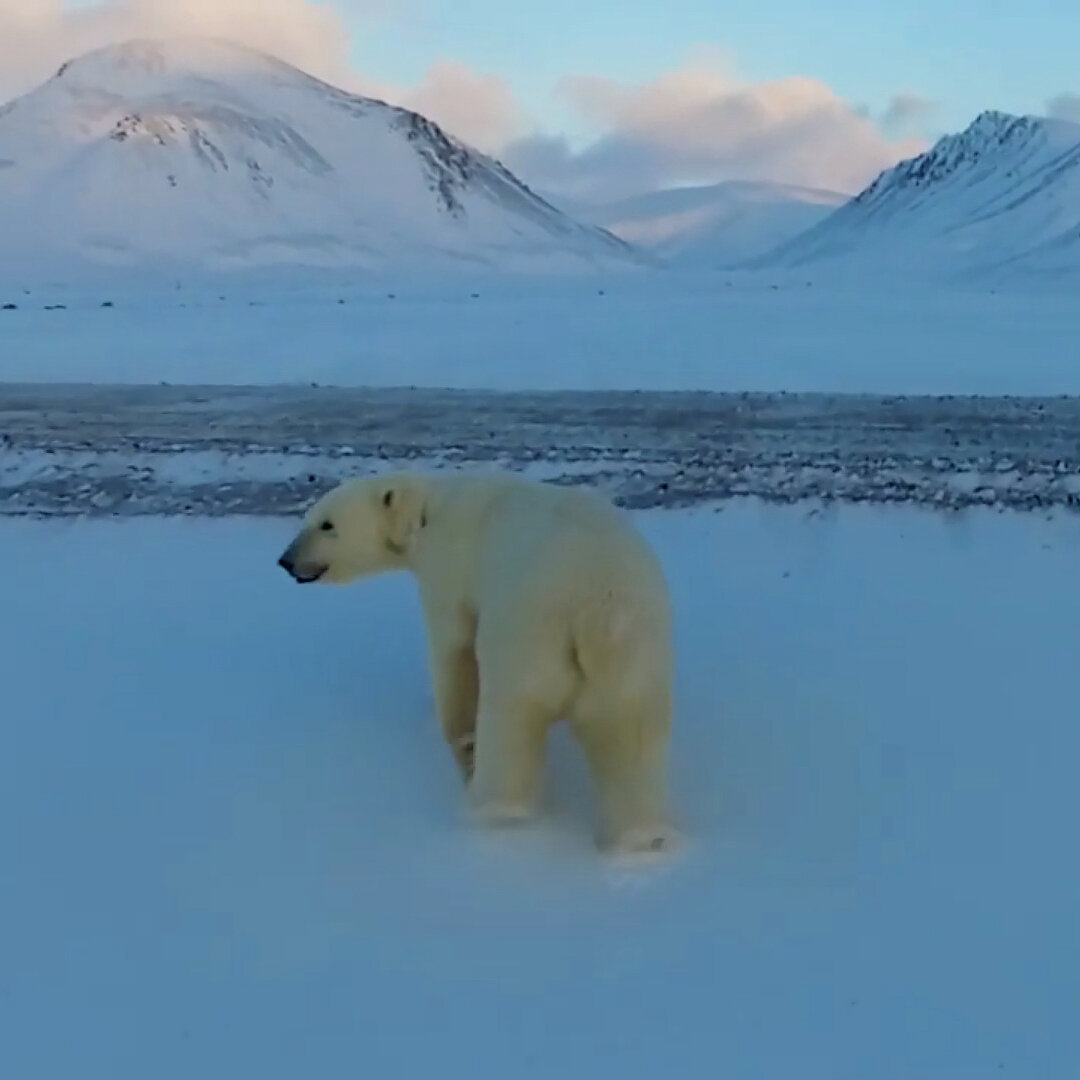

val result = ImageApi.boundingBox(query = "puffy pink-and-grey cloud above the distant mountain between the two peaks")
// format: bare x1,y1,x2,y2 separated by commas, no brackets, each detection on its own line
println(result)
503,60,924,199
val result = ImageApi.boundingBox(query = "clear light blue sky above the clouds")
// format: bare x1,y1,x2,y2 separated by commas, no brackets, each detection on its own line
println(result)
343,0,1080,136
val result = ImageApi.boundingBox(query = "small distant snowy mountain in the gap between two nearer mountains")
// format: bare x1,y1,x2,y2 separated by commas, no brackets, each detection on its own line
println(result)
572,180,847,268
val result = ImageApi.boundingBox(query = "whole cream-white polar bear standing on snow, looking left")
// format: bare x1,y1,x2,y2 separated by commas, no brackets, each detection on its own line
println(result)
279,472,676,853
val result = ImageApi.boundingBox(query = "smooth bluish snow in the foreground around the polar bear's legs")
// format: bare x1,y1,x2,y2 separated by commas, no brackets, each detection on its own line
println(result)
0,502,1080,1080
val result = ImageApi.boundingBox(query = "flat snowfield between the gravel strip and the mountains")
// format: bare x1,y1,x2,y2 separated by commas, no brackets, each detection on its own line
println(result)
6,276,1080,394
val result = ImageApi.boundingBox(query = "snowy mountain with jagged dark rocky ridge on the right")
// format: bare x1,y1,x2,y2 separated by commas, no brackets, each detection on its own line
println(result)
754,112,1080,276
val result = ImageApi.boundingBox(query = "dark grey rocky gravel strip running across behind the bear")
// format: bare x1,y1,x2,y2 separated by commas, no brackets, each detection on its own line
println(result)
0,383,1080,516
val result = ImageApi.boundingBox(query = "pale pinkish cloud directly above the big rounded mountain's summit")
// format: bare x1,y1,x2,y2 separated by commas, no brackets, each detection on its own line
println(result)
0,0,360,102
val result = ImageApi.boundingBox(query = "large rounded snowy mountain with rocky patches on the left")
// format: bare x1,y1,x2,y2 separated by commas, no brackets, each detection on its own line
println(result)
0,39,636,270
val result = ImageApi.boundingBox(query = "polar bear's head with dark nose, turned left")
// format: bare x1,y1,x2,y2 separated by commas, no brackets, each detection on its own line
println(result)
278,473,424,584
